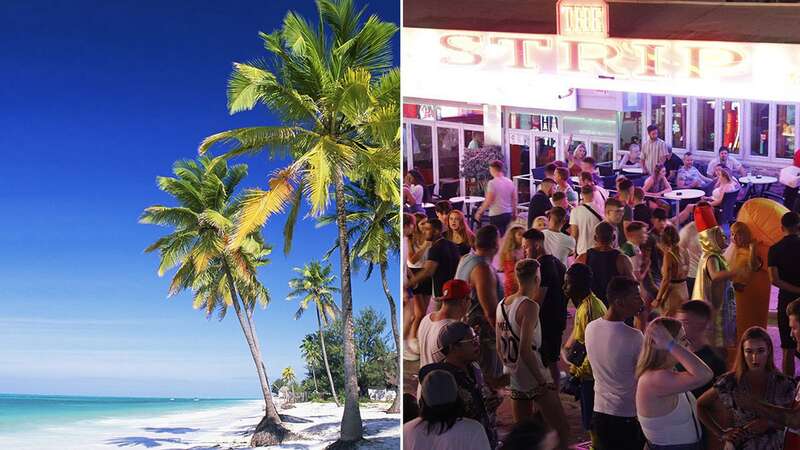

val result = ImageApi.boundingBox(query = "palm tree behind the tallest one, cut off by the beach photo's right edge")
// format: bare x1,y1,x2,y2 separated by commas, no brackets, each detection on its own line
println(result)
319,185,402,413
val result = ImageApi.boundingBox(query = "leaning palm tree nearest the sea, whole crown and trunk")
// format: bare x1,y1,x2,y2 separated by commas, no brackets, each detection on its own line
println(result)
139,157,288,445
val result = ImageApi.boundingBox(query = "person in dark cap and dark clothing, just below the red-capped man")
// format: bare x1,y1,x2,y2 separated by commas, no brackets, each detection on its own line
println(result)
419,322,494,448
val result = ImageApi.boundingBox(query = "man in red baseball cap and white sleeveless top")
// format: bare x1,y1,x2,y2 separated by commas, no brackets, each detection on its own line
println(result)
417,280,470,367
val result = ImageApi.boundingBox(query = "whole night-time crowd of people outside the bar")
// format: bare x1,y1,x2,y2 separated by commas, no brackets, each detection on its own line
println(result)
402,138,800,450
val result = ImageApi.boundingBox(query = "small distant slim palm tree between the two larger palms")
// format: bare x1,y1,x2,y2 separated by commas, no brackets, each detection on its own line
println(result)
286,261,339,406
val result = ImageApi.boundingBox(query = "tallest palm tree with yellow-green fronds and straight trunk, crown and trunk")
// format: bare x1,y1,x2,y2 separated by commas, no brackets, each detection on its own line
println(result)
199,0,400,442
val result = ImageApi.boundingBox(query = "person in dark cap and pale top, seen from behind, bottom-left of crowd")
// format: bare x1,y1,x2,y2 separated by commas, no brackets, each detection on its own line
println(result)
403,370,491,450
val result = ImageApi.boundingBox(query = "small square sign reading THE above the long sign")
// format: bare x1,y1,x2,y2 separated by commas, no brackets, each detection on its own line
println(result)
556,0,608,38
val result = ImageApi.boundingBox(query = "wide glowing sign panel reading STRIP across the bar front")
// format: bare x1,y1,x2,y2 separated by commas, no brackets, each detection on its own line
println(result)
401,26,800,110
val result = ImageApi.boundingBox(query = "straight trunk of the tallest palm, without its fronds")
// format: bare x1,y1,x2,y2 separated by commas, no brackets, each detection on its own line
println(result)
334,168,364,442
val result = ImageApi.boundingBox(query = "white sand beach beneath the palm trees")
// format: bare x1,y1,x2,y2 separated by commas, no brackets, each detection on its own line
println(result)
0,401,400,450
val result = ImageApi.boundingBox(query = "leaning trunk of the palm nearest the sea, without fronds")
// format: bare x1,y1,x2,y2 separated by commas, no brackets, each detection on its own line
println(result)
225,264,288,446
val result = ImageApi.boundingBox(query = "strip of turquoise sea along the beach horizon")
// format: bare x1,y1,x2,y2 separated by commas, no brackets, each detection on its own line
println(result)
0,394,250,434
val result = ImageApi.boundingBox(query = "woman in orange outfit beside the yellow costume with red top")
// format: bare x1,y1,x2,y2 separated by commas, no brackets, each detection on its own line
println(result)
725,222,770,341
